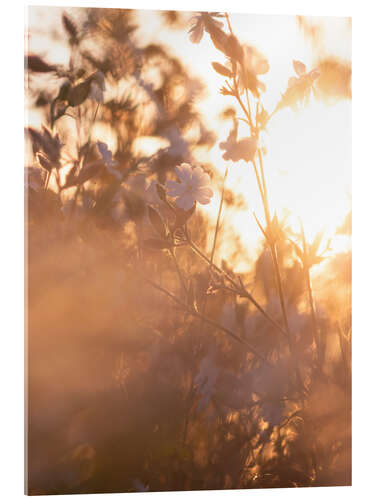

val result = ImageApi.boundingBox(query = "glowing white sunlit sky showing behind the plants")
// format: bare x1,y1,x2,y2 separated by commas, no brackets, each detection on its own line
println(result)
29,7,351,271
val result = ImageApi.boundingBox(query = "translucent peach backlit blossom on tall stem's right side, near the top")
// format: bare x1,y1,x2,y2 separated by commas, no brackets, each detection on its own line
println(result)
239,45,270,97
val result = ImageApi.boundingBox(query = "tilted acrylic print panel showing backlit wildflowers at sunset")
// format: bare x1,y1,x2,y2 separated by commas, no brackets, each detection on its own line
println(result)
25,7,351,495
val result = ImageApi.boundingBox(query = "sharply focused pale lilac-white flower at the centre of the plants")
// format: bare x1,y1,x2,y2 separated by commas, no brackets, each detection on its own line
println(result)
165,163,214,210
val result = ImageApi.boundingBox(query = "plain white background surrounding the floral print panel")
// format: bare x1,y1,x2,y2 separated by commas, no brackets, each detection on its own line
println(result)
0,0,375,500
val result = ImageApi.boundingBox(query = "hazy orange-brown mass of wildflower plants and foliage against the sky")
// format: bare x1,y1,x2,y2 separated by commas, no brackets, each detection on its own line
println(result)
26,5,351,494
